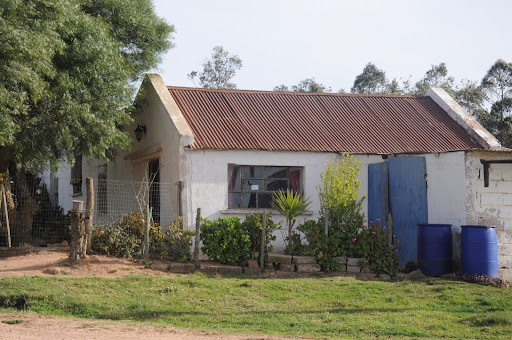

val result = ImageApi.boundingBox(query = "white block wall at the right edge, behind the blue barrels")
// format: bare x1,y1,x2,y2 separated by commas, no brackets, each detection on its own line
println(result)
466,151,512,281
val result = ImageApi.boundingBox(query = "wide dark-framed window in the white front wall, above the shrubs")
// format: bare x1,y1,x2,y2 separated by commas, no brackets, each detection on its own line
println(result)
228,164,302,209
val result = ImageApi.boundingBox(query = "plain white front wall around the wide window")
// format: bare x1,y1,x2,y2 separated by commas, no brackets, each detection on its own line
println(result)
187,150,382,250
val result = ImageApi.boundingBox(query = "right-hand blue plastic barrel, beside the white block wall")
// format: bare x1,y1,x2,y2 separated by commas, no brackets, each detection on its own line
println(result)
460,225,498,278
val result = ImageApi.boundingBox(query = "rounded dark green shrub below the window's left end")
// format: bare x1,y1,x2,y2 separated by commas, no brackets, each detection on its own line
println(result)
200,216,251,264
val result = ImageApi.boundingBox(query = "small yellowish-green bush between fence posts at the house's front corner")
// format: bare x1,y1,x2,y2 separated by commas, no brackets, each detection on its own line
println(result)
165,217,195,262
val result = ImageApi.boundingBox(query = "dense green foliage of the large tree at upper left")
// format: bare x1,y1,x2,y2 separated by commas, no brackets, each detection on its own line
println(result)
0,0,174,170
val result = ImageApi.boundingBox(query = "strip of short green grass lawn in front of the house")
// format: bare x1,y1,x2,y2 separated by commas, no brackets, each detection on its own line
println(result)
0,275,512,339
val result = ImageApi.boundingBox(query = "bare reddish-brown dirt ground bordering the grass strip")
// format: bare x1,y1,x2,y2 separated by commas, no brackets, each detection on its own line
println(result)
0,252,316,340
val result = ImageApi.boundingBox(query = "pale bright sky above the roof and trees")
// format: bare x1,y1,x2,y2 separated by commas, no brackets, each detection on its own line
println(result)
153,0,512,91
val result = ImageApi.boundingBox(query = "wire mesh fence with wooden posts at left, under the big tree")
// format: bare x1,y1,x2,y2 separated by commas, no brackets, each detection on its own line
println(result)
0,176,180,247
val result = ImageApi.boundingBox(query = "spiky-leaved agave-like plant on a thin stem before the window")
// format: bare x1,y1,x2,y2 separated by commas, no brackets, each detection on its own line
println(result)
270,189,311,249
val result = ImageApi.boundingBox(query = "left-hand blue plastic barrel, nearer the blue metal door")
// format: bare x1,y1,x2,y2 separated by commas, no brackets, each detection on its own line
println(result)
417,224,452,276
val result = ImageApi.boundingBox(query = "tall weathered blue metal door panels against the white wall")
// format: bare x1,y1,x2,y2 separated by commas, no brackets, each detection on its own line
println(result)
368,157,428,265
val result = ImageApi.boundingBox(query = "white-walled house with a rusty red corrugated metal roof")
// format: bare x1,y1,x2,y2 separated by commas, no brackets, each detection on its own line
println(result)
47,74,512,279
